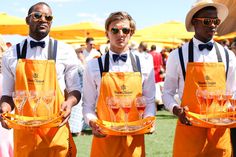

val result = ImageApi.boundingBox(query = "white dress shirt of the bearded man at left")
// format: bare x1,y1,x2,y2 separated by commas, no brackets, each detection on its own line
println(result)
2,36,81,96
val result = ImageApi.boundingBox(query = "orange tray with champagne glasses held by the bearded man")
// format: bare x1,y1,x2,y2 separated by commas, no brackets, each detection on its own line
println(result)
1,90,64,129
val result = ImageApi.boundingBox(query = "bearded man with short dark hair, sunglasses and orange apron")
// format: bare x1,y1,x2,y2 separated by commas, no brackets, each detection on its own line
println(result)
0,2,80,157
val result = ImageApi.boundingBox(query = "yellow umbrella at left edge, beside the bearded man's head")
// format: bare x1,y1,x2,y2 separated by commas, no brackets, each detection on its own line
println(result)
0,13,28,35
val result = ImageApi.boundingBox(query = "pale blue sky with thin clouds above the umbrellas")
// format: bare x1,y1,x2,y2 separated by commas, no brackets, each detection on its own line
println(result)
0,0,196,42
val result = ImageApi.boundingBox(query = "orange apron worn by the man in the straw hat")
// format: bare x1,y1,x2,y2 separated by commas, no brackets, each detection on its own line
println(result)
173,41,231,157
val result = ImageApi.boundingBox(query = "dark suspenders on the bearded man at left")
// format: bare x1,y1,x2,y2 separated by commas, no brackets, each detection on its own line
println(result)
16,38,57,62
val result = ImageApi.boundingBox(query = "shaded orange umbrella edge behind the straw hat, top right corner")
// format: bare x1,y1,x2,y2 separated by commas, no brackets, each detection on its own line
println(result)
214,0,236,35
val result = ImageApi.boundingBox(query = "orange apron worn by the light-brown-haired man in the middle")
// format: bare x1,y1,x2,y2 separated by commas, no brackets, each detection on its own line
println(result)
91,53,145,157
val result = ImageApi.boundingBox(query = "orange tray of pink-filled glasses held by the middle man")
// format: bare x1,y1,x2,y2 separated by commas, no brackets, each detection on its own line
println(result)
97,96,155,136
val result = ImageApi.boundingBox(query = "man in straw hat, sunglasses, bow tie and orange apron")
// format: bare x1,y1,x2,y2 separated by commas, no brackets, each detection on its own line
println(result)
163,0,236,157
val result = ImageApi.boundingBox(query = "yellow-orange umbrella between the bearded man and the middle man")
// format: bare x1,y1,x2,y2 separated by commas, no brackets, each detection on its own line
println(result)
50,22,105,39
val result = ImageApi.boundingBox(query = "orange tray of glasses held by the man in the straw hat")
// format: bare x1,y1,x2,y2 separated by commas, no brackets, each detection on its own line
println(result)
186,88,236,128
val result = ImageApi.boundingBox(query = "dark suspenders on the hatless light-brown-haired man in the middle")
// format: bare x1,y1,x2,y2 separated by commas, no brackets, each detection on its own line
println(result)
98,52,141,77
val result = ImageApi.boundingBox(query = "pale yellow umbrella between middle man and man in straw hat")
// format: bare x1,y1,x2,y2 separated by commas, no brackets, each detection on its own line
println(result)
134,21,194,39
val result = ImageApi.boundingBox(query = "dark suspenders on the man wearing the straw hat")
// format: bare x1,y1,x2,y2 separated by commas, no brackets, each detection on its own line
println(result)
178,39,229,80
